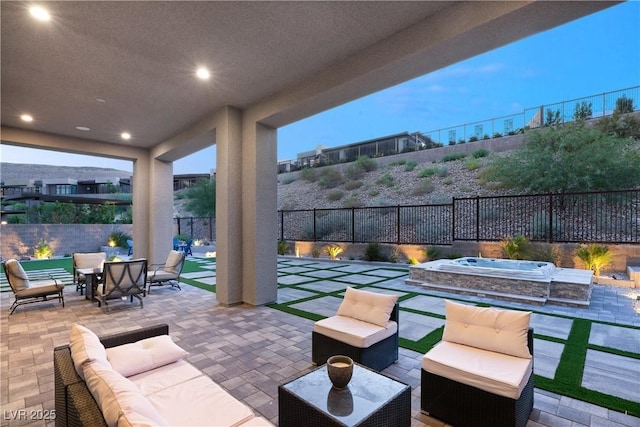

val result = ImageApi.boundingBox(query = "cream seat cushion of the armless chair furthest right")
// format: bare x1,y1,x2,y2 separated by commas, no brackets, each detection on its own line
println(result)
422,341,533,399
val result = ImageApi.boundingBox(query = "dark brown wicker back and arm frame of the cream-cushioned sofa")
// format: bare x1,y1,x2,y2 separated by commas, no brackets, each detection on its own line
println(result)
53,324,169,427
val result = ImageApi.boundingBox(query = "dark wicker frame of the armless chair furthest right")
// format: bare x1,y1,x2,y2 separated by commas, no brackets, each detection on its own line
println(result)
420,328,533,427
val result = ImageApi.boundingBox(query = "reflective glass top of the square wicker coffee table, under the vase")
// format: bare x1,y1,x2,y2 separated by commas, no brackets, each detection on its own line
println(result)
282,364,409,425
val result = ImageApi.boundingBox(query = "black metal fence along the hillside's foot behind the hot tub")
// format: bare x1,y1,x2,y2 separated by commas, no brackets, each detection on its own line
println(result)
278,189,640,245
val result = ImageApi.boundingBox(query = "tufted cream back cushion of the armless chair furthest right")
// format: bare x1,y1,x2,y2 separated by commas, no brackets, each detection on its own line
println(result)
442,301,531,359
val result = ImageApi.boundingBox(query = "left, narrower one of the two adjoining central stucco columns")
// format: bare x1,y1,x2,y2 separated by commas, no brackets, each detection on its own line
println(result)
216,107,244,305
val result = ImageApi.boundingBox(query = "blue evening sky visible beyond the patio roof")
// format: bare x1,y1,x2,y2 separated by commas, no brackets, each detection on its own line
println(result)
0,1,640,174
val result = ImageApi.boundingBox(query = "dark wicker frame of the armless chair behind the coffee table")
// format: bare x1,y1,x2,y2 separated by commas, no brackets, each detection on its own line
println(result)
311,303,400,371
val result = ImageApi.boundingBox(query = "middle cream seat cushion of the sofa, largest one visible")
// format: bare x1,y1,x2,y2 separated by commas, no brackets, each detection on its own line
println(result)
147,375,254,426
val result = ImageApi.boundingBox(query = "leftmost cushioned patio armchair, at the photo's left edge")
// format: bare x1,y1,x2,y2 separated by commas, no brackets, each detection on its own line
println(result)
2,259,64,314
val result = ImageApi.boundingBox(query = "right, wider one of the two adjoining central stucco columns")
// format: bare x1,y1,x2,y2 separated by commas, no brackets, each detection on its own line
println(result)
241,122,278,305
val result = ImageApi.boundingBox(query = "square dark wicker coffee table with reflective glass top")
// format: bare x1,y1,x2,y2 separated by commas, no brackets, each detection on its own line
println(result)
278,363,411,427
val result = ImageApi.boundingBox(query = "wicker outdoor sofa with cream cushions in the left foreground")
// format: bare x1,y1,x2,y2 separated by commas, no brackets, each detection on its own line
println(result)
53,324,272,427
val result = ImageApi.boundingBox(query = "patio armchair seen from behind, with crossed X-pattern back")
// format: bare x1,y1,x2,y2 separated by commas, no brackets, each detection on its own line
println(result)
94,258,147,311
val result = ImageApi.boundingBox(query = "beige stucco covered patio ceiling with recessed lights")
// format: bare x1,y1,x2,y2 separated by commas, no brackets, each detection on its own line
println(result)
0,1,616,160
